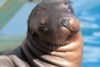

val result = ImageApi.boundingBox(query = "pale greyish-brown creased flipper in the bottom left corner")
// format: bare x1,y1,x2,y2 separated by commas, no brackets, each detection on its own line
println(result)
0,55,30,67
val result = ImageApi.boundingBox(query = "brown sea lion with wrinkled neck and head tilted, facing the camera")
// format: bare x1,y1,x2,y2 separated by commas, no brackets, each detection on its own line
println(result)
0,0,83,67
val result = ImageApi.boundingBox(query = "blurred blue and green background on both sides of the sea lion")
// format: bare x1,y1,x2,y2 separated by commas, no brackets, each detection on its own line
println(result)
0,0,100,67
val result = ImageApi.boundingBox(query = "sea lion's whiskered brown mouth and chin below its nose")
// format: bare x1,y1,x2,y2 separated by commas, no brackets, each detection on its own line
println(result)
44,30,79,47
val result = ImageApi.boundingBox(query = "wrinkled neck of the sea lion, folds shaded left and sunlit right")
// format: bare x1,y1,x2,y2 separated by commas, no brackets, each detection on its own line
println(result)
22,33,81,67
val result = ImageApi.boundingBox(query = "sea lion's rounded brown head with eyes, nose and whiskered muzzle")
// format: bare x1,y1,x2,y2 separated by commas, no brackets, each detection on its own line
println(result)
29,2,80,45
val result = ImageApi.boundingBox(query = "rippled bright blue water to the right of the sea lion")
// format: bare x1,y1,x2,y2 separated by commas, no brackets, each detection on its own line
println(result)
75,0,100,67
